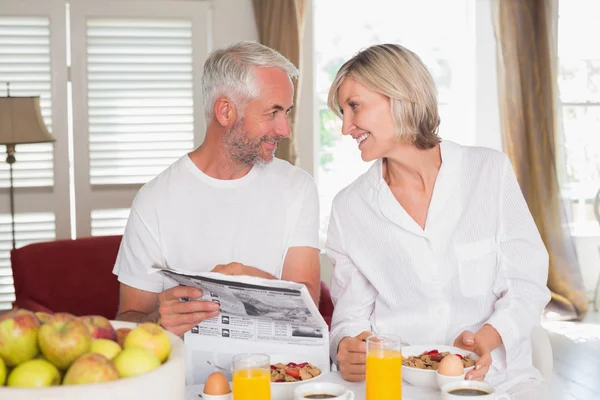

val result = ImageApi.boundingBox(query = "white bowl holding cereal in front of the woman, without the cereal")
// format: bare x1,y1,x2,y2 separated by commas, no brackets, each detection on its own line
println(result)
402,344,479,390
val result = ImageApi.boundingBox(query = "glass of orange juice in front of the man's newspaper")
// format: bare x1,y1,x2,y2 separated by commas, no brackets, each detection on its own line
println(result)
232,354,271,400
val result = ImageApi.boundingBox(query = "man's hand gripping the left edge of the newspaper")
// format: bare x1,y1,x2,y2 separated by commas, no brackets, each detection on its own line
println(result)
158,286,220,336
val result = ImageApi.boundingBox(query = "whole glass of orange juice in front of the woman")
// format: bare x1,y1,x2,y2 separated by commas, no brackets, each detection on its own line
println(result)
366,335,402,400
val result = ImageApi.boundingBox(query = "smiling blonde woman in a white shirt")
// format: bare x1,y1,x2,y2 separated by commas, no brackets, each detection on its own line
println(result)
326,44,550,396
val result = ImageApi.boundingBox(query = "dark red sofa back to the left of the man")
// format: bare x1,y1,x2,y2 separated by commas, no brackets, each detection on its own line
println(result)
11,236,122,319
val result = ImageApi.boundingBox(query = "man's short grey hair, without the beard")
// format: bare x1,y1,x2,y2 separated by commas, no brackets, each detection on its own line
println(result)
202,42,298,123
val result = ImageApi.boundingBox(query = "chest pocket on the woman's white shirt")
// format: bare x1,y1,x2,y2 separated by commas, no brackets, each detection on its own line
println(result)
455,238,498,297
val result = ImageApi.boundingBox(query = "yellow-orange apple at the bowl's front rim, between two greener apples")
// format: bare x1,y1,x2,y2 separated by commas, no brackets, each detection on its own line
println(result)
63,354,119,385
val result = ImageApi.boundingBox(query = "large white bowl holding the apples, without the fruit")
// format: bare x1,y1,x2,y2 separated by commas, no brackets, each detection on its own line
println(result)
0,321,185,400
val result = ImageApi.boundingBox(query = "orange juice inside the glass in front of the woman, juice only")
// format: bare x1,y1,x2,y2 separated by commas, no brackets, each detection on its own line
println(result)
366,349,402,400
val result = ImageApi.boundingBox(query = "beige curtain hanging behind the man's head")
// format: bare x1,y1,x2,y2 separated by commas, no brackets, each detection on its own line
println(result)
252,0,306,164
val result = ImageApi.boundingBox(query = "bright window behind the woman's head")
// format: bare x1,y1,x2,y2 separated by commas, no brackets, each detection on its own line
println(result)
314,0,472,241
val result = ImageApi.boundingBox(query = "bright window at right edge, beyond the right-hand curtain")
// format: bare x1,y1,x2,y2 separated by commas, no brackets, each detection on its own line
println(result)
558,0,600,236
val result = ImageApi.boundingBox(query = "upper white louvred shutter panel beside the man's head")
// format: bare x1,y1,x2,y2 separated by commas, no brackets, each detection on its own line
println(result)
85,17,194,185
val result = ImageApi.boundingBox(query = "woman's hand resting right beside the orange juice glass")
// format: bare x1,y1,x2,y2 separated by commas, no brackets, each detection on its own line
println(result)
337,332,372,382
